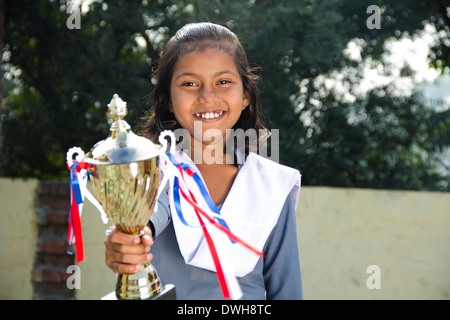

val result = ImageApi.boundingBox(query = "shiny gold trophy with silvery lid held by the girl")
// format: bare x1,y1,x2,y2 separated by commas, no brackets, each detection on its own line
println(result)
69,94,176,300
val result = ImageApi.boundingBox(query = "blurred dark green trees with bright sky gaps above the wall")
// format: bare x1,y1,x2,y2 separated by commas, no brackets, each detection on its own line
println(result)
0,0,450,298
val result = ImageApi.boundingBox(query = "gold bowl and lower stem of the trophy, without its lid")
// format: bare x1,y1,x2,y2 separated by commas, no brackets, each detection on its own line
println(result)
91,157,164,300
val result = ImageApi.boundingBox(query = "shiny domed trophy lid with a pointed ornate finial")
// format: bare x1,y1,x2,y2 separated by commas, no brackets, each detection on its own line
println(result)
85,94,160,165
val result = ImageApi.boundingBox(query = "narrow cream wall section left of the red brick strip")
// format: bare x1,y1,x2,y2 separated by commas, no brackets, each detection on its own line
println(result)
0,178,38,300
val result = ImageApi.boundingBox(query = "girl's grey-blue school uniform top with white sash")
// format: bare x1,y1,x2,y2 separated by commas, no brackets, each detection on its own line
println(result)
150,151,302,300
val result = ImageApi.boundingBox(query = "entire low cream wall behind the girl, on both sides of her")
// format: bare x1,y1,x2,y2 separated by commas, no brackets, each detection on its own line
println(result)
0,178,450,300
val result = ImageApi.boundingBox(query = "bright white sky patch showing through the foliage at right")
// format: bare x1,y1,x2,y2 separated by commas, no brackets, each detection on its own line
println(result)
298,21,450,111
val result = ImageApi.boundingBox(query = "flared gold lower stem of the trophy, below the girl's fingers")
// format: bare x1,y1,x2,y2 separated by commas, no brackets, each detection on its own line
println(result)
116,263,164,300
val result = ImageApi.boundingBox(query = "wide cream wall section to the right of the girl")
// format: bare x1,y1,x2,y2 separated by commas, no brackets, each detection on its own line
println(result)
297,188,450,299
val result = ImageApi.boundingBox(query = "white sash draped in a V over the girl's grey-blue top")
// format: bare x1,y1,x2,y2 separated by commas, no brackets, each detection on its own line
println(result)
169,152,301,277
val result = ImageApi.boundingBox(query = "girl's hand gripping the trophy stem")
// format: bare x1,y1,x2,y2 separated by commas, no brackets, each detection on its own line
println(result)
104,226,153,274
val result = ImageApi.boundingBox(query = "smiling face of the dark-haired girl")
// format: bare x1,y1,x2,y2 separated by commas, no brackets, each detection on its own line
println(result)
170,48,250,144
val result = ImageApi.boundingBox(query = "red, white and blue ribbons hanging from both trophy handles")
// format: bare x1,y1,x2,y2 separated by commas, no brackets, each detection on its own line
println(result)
67,131,263,299
